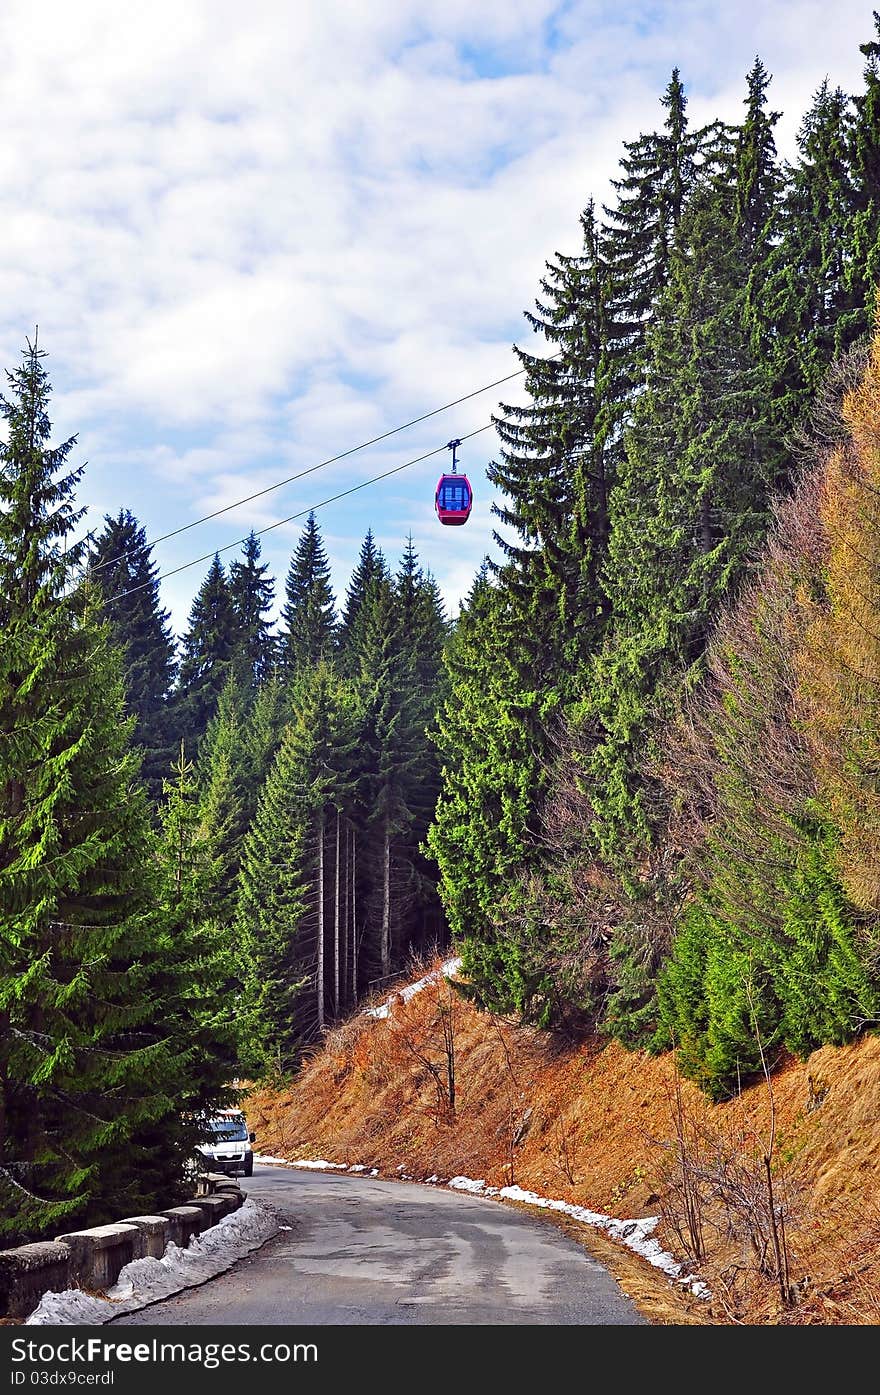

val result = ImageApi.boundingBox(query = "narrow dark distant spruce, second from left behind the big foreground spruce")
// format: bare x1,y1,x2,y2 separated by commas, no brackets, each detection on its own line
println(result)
176,555,238,753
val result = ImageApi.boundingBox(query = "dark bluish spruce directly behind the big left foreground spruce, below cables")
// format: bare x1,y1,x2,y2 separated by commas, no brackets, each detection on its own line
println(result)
89,509,176,804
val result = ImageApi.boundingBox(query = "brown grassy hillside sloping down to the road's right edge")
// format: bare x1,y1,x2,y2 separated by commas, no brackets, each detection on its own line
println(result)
248,965,880,1324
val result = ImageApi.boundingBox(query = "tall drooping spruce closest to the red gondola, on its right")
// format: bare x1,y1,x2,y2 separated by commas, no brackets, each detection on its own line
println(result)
430,205,612,1004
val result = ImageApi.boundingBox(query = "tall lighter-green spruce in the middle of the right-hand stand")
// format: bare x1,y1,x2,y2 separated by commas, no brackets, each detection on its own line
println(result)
584,64,778,862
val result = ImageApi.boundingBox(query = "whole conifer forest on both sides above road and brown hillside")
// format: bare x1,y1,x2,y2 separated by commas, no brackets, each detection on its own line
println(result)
0,17,880,1244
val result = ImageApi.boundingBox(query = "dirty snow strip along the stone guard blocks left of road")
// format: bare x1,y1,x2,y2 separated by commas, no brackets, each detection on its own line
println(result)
25,1197,279,1327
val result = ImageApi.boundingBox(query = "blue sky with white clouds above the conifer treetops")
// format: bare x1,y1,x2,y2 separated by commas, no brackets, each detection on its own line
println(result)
0,0,873,631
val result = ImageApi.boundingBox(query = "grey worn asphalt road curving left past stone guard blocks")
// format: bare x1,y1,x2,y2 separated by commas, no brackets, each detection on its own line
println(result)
113,1163,644,1327
